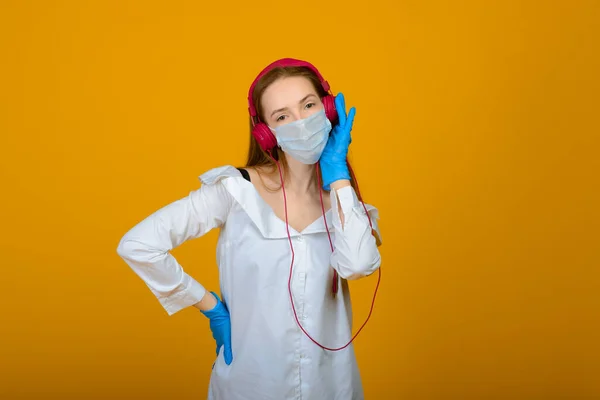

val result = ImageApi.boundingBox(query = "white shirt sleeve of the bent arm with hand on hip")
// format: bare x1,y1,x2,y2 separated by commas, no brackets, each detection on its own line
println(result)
117,181,232,315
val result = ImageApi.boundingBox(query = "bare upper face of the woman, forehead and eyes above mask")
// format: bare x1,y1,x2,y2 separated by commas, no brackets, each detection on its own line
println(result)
261,76,323,128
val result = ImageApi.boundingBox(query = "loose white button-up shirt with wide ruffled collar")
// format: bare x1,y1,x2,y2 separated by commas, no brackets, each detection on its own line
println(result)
117,165,381,400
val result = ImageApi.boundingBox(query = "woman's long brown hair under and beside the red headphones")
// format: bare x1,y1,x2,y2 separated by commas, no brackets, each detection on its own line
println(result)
246,67,362,200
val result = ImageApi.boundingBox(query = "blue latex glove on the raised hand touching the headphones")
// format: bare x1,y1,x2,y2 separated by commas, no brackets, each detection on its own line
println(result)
319,93,356,190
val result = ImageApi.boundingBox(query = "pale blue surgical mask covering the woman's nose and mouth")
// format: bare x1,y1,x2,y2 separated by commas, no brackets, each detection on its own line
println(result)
270,110,331,164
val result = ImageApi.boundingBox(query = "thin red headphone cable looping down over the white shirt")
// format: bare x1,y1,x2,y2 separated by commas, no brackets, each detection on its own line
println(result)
267,150,381,351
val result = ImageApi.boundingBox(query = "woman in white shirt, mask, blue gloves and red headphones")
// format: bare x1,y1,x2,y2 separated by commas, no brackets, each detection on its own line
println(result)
117,59,381,400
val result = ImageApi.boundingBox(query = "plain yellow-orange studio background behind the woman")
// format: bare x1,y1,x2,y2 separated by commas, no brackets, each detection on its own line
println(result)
0,0,600,400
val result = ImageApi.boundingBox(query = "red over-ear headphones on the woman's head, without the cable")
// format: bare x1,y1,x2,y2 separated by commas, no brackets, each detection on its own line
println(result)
248,58,337,152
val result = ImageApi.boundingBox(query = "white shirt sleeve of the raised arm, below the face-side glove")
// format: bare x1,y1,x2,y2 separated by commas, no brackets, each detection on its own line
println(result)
330,186,381,279
